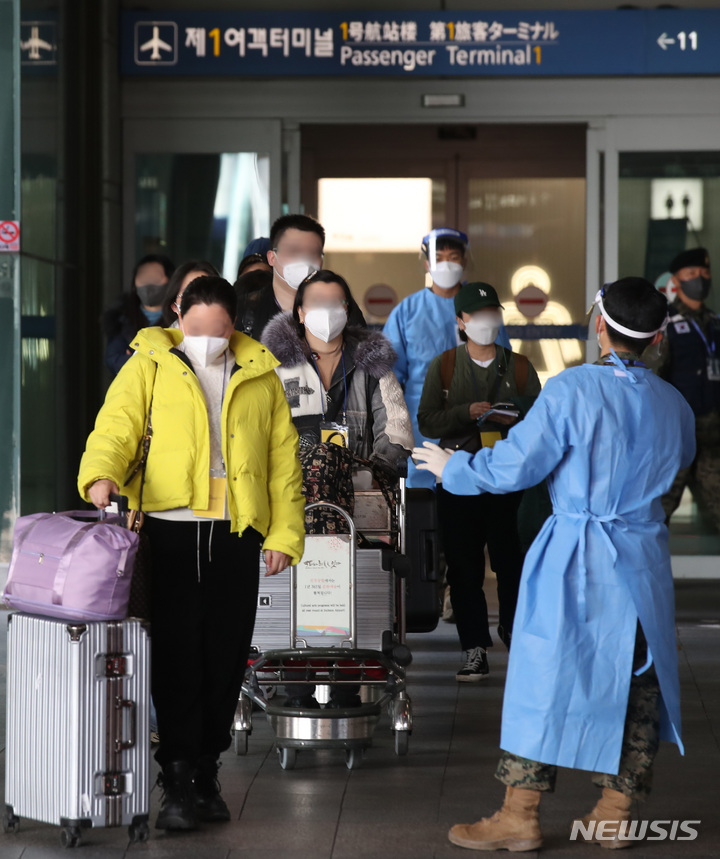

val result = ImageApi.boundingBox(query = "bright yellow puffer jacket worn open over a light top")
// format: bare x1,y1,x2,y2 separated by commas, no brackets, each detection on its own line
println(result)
78,328,305,564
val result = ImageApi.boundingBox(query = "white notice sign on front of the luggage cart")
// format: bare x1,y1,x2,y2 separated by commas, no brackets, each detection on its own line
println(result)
296,534,353,638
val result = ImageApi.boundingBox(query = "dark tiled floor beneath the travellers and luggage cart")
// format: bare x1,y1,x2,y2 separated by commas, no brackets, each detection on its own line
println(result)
0,581,720,859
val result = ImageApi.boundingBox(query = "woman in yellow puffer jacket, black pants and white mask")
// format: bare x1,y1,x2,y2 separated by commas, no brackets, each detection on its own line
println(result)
78,277,304,829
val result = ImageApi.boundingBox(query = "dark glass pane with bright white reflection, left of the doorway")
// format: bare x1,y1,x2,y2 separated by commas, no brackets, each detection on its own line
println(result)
135,152,270,282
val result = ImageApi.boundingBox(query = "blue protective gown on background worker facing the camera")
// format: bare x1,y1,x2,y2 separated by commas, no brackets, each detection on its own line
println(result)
383,289,510,489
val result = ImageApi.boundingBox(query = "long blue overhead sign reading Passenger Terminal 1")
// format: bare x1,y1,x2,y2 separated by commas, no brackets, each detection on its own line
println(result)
121,9,720,77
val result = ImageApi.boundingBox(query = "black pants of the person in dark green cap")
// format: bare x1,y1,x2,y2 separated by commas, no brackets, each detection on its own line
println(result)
437,486,524,650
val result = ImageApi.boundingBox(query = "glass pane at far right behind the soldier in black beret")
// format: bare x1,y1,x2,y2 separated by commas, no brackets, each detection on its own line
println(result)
618,152,720,555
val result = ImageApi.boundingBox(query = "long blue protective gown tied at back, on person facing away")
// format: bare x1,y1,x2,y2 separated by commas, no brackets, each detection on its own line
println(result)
442,359,695,774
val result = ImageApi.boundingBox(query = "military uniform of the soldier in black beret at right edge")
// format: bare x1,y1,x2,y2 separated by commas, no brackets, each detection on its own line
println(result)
658,298,720,531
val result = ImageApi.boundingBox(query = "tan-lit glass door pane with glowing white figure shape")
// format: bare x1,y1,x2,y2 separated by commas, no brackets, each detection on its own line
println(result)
467,177,587,383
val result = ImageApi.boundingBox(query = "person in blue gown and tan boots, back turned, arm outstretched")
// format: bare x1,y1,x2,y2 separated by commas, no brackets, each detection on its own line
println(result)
413,278,695,851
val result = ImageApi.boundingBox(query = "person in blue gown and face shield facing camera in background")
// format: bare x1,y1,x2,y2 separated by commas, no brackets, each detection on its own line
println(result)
383,227,510,489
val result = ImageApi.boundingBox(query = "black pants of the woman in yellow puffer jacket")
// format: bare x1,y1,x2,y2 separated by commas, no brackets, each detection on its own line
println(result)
143,516,261,765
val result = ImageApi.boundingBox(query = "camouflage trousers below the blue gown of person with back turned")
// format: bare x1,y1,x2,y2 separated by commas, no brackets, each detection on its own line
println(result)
495,626,660,799
